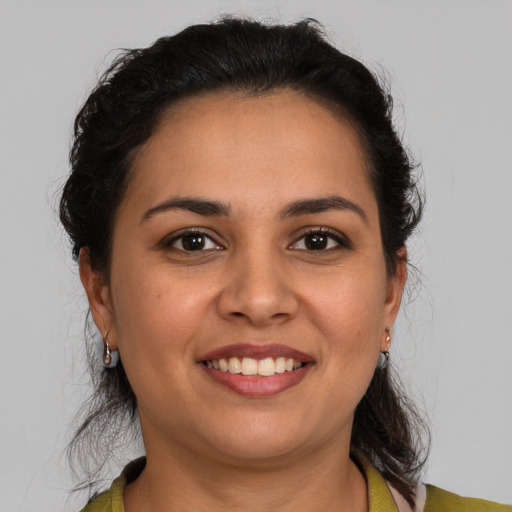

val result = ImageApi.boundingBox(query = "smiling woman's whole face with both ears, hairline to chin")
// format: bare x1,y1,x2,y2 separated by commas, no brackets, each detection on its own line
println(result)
82,92,404,461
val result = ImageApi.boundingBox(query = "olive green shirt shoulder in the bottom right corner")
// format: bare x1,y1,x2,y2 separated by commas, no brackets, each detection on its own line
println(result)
424,485,512,512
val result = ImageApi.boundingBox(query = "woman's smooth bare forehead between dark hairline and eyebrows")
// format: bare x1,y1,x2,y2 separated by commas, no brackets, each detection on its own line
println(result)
127,91,373,218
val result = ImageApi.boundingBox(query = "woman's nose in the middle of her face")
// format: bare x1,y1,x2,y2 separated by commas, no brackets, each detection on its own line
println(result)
217,252,299,327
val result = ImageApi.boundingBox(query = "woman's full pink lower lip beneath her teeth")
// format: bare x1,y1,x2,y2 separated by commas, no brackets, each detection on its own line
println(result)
200,363,313,397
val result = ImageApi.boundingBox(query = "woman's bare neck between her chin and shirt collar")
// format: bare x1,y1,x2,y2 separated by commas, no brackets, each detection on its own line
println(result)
124,434,368,512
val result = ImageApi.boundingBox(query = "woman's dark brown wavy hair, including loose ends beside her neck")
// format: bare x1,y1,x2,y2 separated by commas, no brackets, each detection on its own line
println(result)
60,18,424,503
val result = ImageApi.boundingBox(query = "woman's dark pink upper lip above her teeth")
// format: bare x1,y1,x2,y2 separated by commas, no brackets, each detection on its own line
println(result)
198,343,314,363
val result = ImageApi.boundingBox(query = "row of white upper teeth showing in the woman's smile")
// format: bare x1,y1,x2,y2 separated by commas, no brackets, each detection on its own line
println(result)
206,357,303,377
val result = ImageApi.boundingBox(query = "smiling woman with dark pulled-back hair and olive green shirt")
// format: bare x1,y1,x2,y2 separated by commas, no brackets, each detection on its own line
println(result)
61,19,511,512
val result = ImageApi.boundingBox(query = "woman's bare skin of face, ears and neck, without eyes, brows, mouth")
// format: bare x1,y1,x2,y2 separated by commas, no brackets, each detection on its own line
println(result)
81,91,405,512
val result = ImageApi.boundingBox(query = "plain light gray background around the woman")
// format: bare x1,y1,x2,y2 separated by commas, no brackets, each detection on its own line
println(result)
0,0,512,512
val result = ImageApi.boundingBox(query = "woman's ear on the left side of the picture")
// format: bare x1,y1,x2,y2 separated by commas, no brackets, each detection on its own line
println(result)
79,247,117,350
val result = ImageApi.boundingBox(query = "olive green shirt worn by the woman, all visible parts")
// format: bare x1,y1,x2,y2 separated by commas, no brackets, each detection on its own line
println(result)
82,458,512,512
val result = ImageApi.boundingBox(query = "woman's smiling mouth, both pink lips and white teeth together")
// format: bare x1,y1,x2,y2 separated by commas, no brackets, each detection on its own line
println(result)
198,344,315,397
